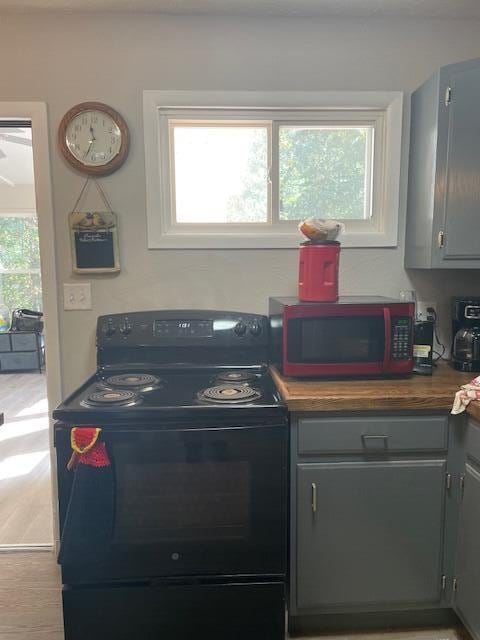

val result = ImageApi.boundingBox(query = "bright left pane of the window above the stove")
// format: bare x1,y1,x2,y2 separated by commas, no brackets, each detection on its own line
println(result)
169,120,271,224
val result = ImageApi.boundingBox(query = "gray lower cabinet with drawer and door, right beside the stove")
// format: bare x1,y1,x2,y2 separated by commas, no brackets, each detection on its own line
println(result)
290,414,452,616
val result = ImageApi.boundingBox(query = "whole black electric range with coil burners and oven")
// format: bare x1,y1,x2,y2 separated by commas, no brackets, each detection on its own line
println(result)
53,310,288,640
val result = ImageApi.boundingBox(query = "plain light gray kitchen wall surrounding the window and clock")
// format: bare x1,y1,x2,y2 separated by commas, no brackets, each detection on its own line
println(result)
0,14,480,391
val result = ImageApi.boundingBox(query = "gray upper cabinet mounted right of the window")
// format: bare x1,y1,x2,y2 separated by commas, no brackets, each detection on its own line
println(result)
405,59,480,269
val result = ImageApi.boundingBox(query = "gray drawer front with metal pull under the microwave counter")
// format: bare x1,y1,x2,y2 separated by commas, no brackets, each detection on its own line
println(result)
298,416,448,454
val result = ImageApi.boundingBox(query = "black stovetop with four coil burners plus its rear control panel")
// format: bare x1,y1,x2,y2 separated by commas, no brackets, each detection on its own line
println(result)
53,309,286,426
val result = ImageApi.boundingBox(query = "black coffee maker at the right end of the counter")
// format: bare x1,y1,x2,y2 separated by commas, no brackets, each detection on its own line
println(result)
452,297,480,371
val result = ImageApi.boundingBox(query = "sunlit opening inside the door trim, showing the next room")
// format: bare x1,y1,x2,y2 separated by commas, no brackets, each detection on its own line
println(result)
0,120,53,547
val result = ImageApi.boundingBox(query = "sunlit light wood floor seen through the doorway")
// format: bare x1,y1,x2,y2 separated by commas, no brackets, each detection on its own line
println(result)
0,373,53,546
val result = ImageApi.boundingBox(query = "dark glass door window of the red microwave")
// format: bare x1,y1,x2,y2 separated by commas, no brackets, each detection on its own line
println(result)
287,315,385,364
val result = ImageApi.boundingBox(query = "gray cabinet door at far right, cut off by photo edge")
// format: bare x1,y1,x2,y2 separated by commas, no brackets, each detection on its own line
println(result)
454,463,480,638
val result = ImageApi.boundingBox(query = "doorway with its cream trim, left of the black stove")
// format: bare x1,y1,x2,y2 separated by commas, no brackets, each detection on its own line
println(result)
0,102,61,551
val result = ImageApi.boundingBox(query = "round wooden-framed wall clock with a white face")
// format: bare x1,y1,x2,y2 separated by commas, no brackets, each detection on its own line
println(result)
58,102,130,176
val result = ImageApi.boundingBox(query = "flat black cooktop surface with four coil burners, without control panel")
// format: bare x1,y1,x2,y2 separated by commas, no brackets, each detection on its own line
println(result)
53,366,285,424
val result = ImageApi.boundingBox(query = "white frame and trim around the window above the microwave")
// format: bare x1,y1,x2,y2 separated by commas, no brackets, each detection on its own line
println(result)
143,91,403,249
